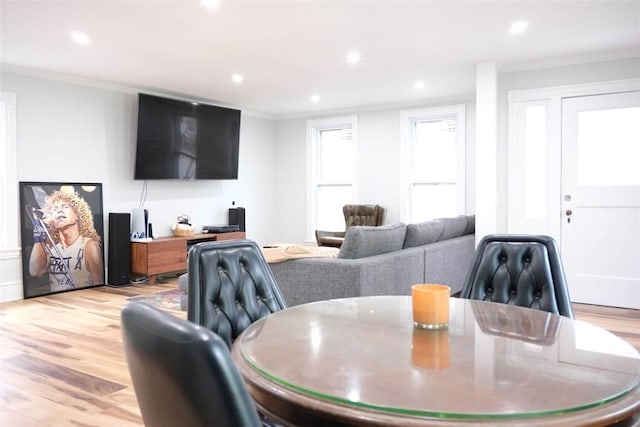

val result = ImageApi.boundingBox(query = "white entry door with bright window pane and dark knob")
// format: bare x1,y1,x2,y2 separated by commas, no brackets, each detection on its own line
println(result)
561,91,640,309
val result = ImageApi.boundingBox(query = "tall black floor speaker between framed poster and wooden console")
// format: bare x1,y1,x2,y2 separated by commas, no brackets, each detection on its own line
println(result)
107,213,131,285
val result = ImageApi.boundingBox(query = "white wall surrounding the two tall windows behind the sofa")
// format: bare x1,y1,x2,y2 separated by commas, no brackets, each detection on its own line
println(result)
276,95,475,242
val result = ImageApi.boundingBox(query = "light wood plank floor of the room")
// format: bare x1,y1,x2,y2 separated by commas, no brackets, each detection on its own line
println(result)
0,280,640,427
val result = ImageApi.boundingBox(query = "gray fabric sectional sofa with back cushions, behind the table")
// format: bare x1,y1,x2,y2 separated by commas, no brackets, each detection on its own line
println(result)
270,215,475,306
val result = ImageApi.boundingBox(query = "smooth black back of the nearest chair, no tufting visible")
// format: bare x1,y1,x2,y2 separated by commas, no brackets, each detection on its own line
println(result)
121,302,261,427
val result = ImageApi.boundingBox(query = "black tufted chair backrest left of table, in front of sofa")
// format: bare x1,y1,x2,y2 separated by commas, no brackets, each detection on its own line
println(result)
187,240,287,347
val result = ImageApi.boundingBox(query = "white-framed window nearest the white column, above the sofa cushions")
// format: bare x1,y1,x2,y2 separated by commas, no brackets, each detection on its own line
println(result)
400,105,465,222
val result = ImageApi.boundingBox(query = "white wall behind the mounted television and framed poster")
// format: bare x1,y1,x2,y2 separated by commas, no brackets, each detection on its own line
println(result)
0,73,278,300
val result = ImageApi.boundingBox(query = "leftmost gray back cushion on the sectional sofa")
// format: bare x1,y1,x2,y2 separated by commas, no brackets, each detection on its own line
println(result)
338,223,407,259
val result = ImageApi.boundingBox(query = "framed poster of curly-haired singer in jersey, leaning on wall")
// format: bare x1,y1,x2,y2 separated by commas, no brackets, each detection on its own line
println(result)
20,182,104,298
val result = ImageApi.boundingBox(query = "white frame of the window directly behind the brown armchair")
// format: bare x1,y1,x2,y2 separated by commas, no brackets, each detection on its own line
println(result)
306,115,358,242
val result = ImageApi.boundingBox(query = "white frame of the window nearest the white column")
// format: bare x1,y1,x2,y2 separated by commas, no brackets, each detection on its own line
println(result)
400,104,466,222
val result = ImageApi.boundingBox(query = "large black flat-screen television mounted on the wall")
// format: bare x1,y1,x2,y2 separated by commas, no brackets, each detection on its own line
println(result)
134,93,240,179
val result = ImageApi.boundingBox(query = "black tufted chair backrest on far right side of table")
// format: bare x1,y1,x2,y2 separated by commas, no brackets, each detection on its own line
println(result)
460,234,574,318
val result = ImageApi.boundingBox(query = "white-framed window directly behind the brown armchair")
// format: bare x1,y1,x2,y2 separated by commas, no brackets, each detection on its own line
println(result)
307,116,357,236
